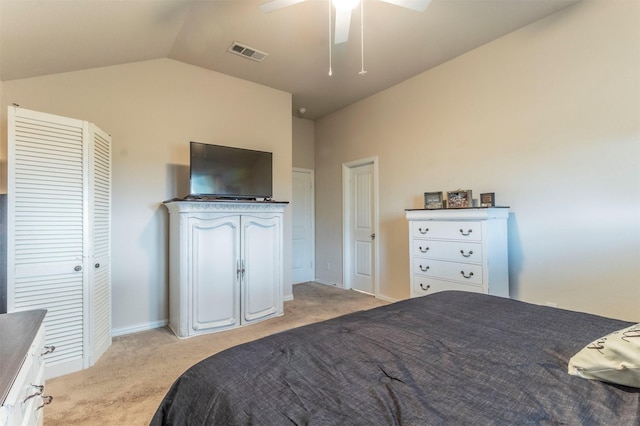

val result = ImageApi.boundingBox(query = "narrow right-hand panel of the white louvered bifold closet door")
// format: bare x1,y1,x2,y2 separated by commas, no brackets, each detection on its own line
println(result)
88,125,111,365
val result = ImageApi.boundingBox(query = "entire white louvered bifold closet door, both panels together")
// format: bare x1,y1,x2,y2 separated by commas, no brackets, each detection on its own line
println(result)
7,106,111,377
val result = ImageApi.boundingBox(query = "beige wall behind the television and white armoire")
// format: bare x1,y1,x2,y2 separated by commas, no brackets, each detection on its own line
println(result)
1,59,292,334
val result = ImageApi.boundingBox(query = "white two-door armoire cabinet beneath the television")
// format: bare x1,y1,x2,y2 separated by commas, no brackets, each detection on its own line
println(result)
165,201,286,337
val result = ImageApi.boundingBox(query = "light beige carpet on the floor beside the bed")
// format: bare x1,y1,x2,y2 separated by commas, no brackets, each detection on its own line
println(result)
44,283,387,426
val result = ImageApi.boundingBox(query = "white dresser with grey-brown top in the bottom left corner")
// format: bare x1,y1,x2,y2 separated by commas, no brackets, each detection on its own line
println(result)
0,309,54,426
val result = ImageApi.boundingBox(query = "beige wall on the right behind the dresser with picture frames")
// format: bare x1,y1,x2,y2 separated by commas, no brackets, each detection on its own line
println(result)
315,0,640,321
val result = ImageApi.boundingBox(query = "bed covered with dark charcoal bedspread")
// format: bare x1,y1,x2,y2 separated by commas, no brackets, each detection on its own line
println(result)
151,291,640,425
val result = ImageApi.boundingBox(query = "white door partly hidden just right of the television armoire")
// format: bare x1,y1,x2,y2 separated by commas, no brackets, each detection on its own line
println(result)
291,169,315,284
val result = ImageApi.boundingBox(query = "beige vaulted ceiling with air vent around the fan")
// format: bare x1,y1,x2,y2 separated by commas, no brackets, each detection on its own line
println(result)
0,0,578,119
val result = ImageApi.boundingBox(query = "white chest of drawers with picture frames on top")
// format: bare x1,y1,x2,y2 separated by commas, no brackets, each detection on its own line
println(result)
406,207,509,297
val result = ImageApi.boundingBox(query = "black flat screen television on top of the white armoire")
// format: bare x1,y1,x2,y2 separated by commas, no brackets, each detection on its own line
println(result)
189,142,273,199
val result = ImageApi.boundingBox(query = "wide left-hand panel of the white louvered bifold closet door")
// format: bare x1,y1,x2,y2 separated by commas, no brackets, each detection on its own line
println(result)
7,107,87,375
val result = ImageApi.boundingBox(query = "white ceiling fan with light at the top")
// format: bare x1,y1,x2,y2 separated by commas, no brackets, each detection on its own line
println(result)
260,0,431,44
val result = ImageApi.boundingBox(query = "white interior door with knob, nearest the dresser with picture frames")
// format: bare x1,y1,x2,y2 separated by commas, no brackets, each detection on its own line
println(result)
349,163,375,294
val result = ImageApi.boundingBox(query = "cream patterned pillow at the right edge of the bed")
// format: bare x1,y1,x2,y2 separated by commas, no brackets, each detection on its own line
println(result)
569,324,640,388
